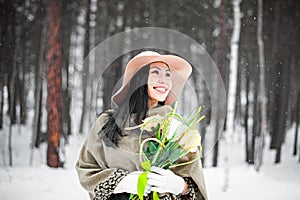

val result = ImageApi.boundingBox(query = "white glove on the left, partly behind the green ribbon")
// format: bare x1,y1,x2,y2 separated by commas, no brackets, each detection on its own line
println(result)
113,171,151,196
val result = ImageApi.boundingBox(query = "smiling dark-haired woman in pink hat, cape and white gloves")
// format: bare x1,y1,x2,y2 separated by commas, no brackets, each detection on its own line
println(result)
76,51,207,200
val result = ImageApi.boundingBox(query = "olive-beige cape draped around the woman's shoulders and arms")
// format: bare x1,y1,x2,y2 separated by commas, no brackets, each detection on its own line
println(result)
76,106,207,200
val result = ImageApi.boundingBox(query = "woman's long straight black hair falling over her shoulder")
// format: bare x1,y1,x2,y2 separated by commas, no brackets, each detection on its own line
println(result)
99,64,154,147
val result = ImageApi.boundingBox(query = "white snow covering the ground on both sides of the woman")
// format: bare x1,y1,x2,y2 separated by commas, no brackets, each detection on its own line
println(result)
0,125,300,200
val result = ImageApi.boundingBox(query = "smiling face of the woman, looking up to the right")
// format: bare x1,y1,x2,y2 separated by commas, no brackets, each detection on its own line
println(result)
148,62,172,108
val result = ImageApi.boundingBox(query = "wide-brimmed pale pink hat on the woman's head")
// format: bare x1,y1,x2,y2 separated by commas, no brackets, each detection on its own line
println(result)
111,51,192,105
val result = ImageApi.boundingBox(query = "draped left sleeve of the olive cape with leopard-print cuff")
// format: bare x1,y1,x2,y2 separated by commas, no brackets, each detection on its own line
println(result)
75,112,129,200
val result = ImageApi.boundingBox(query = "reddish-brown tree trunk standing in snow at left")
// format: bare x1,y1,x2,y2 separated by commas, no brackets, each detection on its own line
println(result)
46,0,63,168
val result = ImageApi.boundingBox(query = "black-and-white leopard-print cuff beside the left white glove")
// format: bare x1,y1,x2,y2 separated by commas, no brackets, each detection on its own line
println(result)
93,169,129,200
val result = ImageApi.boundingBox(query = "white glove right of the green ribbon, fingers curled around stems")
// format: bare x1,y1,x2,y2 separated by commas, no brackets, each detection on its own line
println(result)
147,166,185,195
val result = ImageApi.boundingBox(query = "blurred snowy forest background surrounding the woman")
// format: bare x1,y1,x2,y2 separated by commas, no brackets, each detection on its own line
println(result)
0,0,300,200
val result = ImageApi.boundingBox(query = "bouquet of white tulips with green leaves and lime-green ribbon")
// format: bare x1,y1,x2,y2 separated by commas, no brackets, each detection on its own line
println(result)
127,102,204,200
